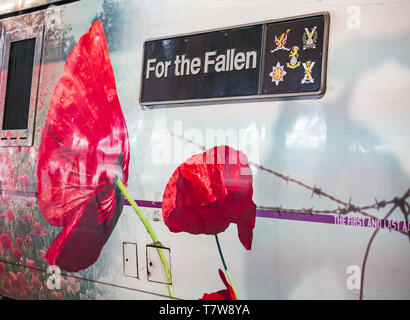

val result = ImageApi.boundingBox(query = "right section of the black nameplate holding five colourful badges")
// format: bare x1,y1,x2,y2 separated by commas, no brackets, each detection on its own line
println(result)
261,15,325,95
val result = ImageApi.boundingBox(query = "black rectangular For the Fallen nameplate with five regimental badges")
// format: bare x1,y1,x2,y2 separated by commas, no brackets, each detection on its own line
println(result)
140,13,328,105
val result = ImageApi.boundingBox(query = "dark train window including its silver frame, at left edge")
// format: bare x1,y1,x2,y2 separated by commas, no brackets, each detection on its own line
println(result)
0,26,43,146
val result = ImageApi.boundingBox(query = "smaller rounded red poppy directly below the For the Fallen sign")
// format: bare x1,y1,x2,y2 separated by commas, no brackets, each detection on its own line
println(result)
162,146,256,250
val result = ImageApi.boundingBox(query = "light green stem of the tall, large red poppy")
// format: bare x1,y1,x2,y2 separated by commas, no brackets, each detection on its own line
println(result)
115,178,175,299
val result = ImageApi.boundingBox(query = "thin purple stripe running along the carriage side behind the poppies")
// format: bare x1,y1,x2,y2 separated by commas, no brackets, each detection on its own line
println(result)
0,190,410,231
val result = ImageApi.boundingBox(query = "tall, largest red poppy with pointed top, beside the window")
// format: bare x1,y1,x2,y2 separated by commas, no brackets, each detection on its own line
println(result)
37,20,129,271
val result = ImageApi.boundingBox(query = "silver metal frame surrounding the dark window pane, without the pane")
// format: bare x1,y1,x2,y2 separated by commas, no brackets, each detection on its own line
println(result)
0,25,44,147
